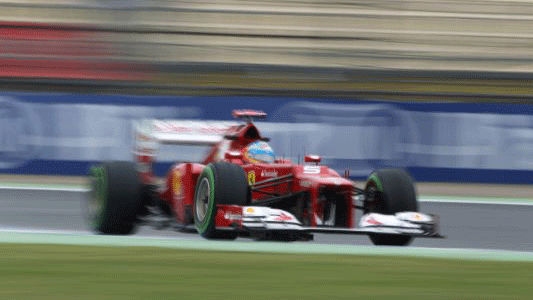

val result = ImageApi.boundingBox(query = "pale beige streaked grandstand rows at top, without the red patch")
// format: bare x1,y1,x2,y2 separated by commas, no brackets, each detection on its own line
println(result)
0,0,533,71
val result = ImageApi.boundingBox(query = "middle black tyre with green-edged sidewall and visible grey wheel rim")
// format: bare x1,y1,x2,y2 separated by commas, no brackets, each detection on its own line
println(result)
193,162,250,240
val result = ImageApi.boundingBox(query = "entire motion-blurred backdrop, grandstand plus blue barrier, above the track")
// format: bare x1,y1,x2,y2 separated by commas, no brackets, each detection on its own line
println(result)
0,0,533,183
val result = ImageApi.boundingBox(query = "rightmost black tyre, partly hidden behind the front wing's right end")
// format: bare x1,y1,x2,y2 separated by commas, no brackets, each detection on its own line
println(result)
364,169,418,246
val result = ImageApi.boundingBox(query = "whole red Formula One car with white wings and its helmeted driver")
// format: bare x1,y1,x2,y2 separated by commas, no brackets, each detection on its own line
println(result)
85,110,442,245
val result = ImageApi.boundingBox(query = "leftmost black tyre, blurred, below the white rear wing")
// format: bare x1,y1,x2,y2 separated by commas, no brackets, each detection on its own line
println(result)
84,162,142,235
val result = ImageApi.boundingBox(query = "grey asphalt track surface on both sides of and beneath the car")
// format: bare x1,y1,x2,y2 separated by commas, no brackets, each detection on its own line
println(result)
0,189,533,251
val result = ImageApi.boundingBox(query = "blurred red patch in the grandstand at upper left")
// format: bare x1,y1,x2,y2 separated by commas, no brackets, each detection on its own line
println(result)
0,21,147,81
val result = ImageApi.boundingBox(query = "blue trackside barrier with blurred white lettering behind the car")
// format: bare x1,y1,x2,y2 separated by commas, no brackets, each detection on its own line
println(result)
0,93,533,183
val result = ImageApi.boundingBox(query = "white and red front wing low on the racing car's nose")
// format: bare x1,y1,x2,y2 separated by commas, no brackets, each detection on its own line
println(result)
215,205,444,238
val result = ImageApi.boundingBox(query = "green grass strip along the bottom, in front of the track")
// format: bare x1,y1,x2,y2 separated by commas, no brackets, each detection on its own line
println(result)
0,244,533,300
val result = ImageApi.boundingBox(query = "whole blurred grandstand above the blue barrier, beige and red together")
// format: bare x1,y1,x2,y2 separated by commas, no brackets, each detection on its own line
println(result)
0,0,533,100
